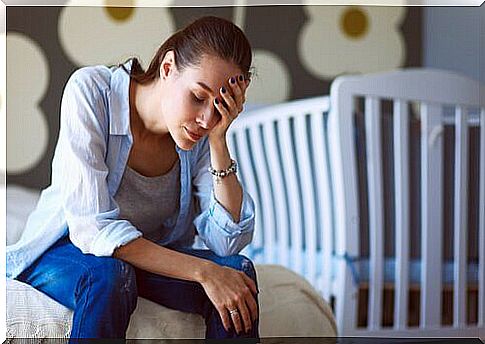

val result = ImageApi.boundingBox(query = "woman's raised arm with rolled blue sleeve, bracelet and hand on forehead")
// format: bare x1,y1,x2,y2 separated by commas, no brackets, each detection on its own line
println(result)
193,78,255,256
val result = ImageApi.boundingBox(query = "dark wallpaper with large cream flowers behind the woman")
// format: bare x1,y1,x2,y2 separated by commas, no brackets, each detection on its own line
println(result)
1,1,422,188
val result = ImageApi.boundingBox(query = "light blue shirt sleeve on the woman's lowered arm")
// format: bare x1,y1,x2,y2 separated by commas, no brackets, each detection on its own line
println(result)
53,70,142,256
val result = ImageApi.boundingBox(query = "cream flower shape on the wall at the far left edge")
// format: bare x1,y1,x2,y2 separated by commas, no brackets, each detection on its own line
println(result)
6,32,49,174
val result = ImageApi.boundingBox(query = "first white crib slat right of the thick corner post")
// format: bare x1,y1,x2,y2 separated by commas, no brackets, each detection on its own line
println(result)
365,97,384,329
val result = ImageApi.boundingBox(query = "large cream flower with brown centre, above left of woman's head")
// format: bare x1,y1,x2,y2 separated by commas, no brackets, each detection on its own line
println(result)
58,0,175,66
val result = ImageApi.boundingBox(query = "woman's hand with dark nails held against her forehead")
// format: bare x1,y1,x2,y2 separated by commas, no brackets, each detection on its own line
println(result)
209,75,250,141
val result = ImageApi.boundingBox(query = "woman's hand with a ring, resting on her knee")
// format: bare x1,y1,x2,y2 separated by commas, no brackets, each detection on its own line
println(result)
200,264,258,334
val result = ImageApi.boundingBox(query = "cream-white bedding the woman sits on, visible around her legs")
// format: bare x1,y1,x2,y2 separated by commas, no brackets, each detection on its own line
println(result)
6,186,337,338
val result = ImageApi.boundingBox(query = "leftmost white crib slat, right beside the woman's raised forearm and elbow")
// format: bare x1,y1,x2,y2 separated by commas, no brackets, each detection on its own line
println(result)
236,130,264,263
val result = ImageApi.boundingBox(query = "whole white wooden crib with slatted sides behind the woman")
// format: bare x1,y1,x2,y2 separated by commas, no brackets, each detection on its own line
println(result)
229,69,485,338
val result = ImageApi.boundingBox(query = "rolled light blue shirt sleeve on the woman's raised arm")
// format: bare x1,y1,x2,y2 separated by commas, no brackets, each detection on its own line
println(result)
193,138,254,256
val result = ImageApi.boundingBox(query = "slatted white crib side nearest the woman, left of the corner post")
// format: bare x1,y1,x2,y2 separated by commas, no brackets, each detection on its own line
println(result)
228,97,333,298
